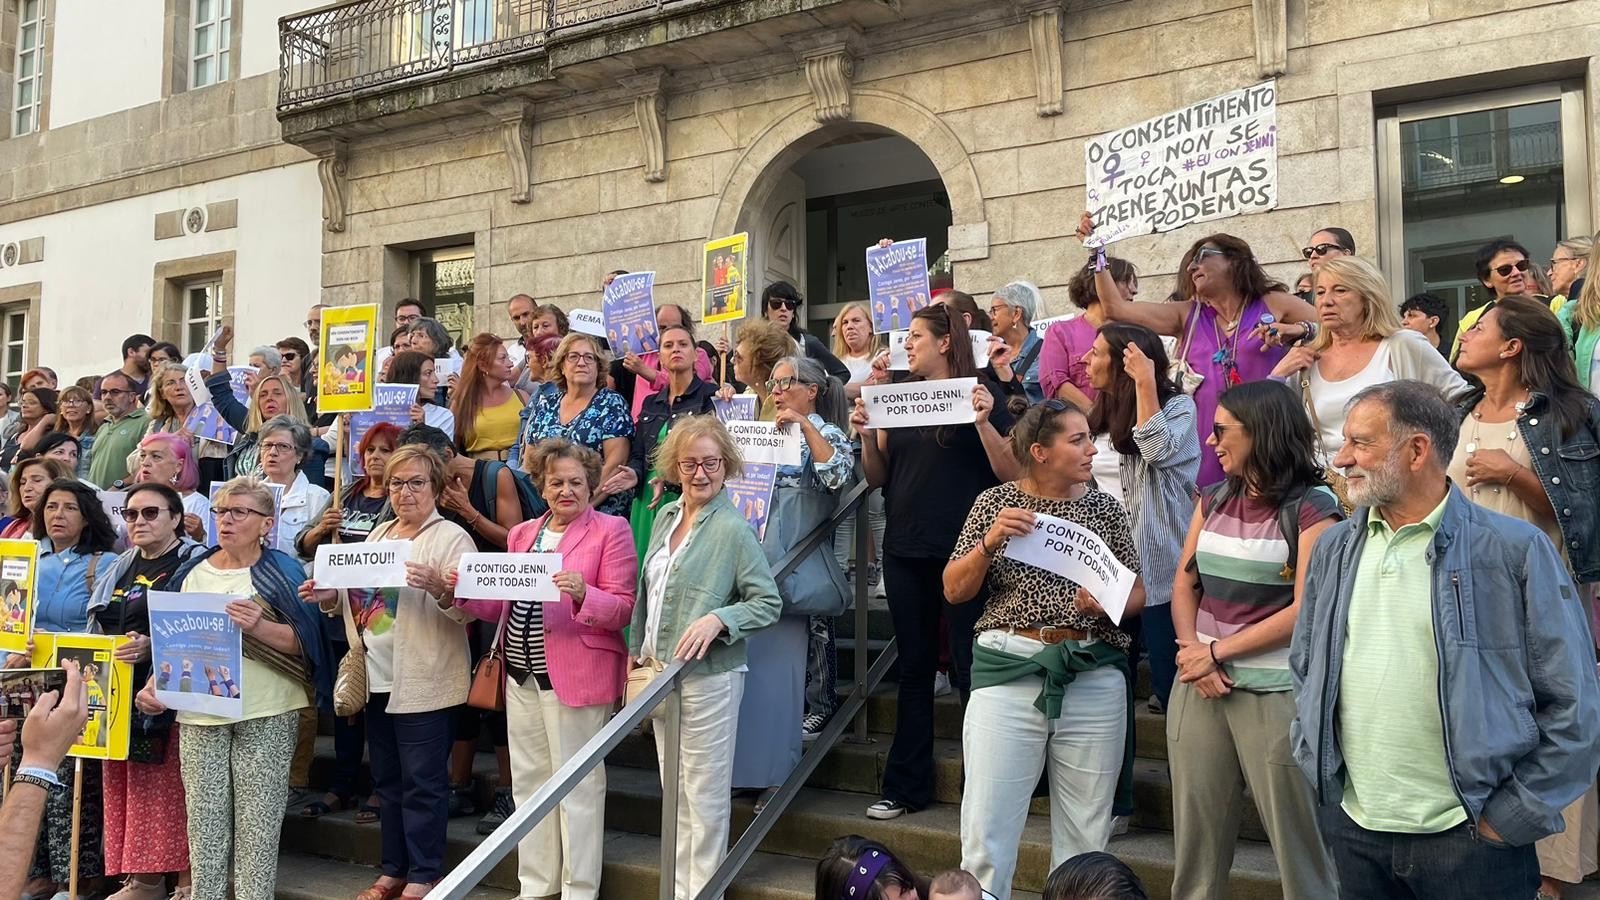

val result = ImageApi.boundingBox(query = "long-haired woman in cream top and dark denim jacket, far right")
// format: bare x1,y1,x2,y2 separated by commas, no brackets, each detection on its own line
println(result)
1450,296,1600,898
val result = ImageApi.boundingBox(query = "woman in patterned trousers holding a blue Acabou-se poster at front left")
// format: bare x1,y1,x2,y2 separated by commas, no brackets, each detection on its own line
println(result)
134,477,333,900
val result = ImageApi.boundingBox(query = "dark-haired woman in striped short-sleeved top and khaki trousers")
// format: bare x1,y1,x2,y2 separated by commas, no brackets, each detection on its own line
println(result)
1166,381,1342,900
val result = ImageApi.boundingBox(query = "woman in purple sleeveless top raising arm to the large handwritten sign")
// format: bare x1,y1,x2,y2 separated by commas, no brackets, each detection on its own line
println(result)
1078,213,1315,487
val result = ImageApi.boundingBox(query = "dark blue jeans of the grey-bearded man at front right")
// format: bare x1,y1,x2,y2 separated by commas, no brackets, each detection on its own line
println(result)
1317,806,1539,900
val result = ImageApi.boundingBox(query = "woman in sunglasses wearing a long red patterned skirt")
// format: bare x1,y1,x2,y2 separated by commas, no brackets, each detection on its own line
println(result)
90,483,206,900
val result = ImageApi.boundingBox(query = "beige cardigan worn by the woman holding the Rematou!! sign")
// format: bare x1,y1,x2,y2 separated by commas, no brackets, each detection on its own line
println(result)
339,511,478,714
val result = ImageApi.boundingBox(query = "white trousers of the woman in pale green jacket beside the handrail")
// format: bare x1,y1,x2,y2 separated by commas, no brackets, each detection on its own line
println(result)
654,673,744,900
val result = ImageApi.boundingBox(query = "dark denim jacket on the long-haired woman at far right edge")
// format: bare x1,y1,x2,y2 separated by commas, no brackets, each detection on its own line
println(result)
1456,391,1600,585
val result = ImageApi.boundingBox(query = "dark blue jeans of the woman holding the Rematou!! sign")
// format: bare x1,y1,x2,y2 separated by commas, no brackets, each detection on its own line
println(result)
366,693,451,884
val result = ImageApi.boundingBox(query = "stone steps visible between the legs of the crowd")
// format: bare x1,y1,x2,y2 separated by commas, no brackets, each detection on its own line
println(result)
268,602,1600,900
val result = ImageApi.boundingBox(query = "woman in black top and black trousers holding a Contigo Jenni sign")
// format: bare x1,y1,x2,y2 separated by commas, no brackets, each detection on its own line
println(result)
850,304,1021,818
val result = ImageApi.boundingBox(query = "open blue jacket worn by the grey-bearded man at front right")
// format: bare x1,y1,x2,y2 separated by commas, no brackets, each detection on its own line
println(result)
1290,485,1600,847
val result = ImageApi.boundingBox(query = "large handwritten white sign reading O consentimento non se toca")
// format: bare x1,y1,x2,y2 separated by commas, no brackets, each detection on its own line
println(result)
1083,82,1278,247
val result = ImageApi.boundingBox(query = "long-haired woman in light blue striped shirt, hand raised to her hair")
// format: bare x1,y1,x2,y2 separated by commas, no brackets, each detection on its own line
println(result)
1083,322,1200,708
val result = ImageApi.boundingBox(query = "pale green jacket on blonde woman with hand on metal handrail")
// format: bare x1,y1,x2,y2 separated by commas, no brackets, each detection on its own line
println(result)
627,493,784,674
